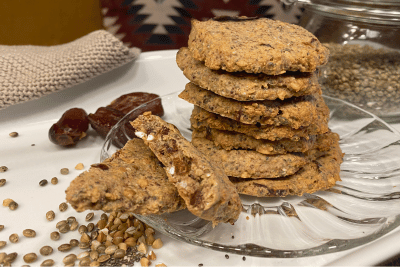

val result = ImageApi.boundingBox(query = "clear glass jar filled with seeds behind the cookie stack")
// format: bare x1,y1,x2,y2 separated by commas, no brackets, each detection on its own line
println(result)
286,0,400,121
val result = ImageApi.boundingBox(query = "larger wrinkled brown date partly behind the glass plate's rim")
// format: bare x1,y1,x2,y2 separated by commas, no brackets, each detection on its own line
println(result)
89,92,164,147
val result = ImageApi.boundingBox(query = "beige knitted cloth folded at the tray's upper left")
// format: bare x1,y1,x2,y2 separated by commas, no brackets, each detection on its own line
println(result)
0,30,140,109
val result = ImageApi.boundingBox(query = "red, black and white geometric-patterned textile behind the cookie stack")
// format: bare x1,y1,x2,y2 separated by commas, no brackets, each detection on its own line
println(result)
100,0,302,51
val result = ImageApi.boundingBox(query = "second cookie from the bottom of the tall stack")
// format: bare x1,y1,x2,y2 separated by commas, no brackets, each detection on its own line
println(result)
192,137,308,178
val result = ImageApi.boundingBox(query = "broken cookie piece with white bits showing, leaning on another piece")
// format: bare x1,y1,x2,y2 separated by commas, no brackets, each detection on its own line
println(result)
131,113,242,225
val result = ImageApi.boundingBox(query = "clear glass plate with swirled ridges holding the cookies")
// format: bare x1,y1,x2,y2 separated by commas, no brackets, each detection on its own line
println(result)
101,92,400,258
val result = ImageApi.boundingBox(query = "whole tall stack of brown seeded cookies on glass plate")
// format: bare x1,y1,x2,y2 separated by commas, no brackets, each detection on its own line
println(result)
177,17,343,197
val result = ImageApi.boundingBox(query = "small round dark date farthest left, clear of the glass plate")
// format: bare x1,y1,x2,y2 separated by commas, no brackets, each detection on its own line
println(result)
49,108,89,146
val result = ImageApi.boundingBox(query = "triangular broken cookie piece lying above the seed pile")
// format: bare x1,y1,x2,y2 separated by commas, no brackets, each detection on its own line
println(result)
66,138,185,215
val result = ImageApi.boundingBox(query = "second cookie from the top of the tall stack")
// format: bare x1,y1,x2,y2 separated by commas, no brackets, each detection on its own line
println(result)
176,47,321,101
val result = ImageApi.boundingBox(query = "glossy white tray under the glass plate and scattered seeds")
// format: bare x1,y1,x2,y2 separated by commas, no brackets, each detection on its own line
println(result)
0,51,400,266
